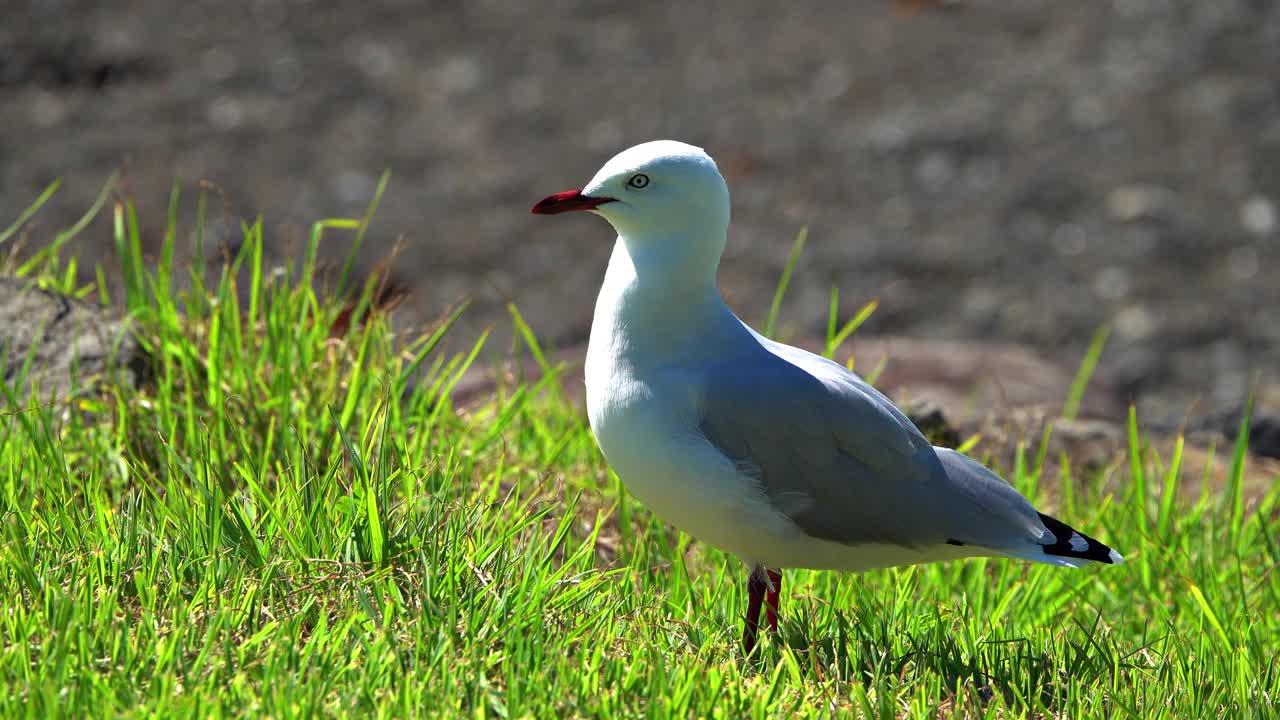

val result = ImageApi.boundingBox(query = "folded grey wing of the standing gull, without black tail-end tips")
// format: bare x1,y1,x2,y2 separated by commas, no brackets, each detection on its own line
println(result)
700,338,1047,548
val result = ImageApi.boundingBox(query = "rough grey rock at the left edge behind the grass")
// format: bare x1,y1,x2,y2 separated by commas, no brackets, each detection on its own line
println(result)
0,277,146,405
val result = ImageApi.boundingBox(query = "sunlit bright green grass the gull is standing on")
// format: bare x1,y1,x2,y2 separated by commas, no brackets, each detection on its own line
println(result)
0,181,1280,719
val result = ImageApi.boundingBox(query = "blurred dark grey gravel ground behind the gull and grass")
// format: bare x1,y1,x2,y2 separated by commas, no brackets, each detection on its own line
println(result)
0,0,1280,416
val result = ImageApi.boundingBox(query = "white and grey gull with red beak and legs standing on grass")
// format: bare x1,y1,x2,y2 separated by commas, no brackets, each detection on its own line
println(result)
532,140,1123,656
